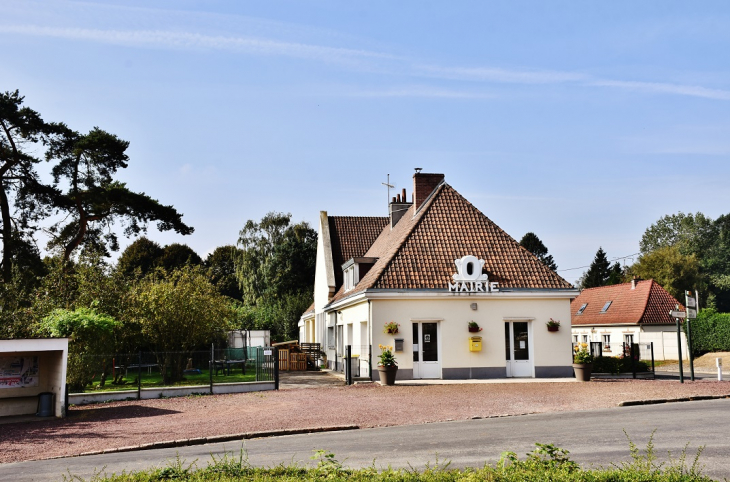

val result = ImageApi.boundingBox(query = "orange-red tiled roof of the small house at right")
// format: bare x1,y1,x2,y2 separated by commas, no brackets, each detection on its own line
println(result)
570,280,684,325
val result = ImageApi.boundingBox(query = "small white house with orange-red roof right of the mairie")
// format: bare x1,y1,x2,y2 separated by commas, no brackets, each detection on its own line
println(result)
570,280,687,360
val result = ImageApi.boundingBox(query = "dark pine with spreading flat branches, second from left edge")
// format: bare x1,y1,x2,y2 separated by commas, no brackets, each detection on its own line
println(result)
44,127,193,260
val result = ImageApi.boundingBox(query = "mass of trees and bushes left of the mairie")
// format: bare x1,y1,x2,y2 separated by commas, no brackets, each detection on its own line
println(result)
0,91,316,389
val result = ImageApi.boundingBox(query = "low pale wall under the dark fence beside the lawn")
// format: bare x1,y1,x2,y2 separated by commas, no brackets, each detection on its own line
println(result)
68,382,274,405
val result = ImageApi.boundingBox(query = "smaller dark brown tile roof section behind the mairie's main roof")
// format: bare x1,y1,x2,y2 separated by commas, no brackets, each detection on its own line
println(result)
327,216,390,289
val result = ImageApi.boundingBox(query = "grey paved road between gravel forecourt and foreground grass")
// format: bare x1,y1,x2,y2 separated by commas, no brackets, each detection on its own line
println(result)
0,400,730,482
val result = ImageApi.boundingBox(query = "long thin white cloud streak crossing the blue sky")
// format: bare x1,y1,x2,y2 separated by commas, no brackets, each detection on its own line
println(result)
5,25,730,101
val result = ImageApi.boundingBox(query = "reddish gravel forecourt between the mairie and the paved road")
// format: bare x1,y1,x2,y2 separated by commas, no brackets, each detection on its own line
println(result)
0,380,730,462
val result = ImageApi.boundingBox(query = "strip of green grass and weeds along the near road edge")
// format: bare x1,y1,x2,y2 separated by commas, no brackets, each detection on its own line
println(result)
64,433,712,482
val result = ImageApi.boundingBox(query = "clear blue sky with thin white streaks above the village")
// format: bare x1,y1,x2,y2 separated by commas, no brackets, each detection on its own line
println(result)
0,0,730,281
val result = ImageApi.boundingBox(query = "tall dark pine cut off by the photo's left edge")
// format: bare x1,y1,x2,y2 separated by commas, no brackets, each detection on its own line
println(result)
0,90,54,283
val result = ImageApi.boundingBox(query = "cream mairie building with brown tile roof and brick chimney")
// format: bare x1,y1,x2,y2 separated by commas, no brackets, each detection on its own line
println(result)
300,172,578,380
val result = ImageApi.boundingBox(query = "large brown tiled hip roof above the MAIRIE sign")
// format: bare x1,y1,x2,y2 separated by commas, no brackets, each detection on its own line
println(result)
333,183,572,301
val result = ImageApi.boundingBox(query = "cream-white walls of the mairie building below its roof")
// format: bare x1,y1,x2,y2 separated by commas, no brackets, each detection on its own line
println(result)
329,291,575,380
